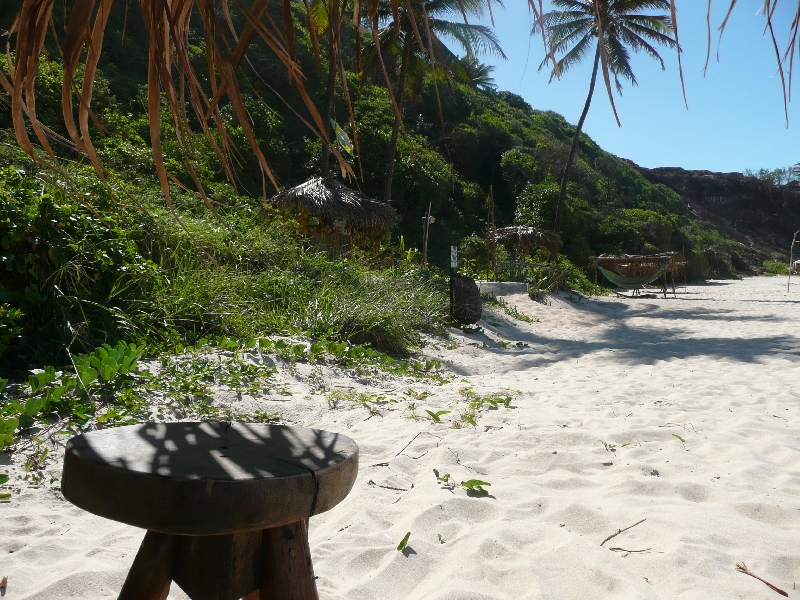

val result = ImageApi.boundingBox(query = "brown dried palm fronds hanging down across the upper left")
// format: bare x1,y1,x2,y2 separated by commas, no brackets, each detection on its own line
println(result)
0,0,547,211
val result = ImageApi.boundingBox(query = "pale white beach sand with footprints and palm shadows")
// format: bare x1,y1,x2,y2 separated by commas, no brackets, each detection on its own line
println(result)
0,277,800,600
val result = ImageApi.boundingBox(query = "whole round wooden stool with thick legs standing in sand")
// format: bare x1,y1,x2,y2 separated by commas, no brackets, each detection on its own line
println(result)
61,423,358,600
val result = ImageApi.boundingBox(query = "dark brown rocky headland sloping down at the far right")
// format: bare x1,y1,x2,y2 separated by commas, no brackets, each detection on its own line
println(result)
628,161,800,258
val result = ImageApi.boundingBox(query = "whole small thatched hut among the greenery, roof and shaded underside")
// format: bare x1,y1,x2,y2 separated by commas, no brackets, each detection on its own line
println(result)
266,177,400,254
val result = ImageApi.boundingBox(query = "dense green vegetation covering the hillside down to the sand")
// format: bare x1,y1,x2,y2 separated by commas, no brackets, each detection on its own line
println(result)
0,2,780,374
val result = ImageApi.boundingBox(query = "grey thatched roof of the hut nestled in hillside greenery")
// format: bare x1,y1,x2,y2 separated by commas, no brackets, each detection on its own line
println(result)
267,177,400,229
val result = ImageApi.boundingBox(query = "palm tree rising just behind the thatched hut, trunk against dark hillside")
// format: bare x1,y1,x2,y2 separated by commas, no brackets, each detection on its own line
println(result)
363,0,506,202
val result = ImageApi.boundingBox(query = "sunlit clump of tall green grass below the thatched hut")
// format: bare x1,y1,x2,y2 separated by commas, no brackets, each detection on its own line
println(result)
141,210,447,354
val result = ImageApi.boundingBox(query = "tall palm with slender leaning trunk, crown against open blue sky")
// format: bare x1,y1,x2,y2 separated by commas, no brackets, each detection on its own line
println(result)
532,0,677,233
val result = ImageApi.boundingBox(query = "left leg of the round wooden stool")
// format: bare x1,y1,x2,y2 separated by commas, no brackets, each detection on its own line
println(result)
118,531,175,600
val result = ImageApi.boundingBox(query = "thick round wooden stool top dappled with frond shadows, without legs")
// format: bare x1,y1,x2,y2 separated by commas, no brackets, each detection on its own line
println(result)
61,422,358,535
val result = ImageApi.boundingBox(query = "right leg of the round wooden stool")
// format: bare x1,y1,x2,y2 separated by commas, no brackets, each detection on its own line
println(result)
260,521,319,600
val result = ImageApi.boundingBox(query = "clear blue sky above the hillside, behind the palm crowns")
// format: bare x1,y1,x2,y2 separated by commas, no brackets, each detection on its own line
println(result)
462,0,800,172
